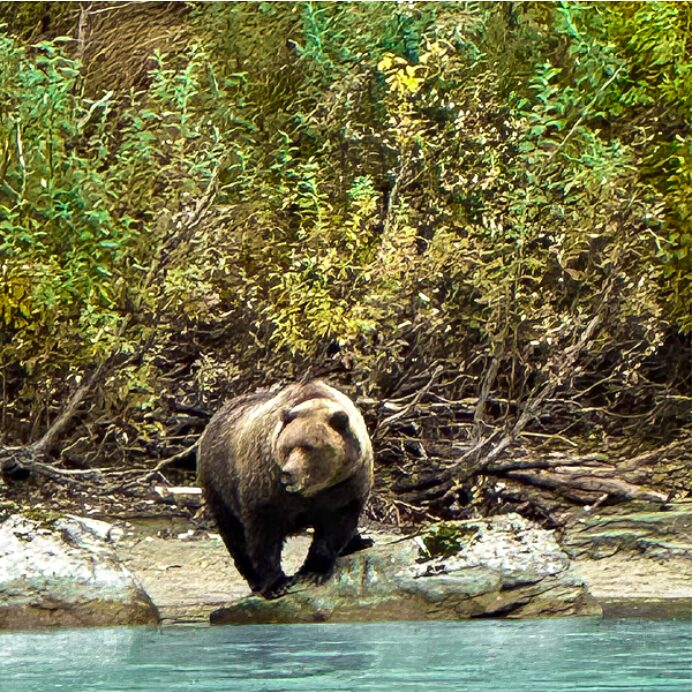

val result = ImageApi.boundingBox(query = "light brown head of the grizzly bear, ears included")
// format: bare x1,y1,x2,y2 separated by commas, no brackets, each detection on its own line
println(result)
274,399,361,497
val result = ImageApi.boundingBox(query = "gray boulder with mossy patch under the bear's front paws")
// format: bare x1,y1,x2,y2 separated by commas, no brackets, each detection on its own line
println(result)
210,514,601,624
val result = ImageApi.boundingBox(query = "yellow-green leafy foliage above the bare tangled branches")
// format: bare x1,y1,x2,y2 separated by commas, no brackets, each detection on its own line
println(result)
0,2,691,460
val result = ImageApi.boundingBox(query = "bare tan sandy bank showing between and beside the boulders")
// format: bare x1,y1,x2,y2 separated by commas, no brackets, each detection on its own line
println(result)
114,504,691,624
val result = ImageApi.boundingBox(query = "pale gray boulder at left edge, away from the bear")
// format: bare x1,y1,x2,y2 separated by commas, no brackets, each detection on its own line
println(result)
0,514,159,629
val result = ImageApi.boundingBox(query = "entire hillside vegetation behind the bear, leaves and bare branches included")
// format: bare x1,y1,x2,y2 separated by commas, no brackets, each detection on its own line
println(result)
0,2,691,524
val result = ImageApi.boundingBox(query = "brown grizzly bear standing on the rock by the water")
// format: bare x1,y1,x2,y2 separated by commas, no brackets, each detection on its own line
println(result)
198,380,373,598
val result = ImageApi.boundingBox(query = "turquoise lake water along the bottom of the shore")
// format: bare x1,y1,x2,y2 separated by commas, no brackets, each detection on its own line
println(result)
0,618,691,692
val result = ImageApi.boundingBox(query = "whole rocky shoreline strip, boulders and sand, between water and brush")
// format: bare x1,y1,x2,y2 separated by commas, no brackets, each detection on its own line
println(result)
0,504,691,629
